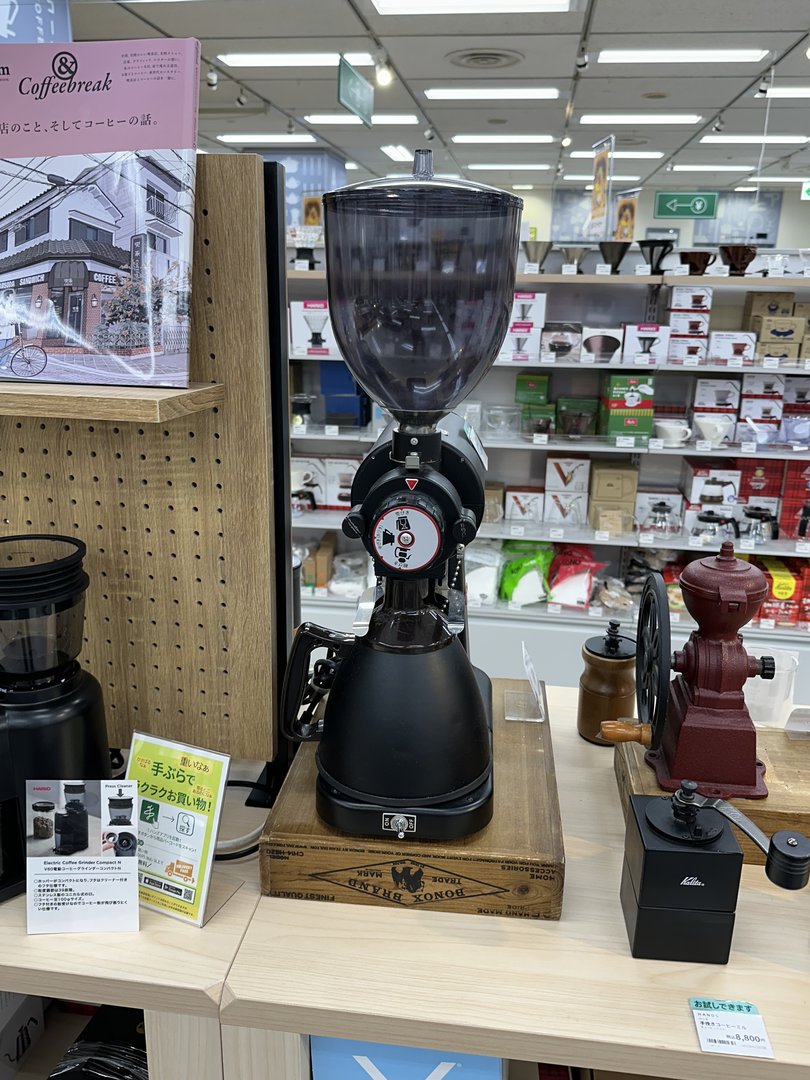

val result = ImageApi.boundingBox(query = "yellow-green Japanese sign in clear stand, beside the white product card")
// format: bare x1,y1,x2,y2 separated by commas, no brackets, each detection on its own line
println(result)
126,731,230,927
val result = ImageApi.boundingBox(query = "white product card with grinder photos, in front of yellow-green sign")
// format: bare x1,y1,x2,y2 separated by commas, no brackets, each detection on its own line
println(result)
26,780,138,934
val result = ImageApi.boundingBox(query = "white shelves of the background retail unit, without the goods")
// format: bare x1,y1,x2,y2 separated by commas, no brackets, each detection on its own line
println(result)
288,270,810,700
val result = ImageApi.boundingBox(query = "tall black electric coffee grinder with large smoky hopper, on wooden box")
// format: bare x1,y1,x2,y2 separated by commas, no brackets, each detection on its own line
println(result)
282,150,522,839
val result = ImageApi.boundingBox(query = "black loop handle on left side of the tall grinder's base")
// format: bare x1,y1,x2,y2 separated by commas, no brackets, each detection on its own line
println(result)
281,622,356,742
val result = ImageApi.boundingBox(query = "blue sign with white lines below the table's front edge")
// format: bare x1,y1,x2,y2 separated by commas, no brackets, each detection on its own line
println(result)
310,1035,505,1080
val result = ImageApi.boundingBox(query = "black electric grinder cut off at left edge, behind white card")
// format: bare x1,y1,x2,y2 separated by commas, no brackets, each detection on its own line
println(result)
0,536,110,900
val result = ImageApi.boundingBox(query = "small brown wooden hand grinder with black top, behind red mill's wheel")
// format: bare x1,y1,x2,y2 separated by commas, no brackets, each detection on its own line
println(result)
577,620,636,746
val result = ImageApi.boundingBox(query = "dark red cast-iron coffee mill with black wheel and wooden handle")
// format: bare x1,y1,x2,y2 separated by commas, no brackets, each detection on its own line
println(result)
602,540,774,799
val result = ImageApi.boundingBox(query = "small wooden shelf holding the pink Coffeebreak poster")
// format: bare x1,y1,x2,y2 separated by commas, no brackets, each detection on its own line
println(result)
0,382,225,423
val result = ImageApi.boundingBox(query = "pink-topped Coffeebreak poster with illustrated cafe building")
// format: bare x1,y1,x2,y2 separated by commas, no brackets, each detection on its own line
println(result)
0,40,198,387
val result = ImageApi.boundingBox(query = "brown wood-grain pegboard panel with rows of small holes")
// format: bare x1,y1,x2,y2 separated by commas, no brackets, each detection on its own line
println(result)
0,154,286,760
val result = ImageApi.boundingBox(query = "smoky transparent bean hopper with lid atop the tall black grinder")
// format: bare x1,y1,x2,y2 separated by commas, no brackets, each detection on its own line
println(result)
324,150,523,427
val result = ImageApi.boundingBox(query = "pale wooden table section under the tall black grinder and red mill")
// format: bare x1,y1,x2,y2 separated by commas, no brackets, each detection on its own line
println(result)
221,688,810,1080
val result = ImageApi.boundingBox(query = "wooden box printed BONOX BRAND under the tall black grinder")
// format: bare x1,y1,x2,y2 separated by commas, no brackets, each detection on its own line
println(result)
259,679,565,919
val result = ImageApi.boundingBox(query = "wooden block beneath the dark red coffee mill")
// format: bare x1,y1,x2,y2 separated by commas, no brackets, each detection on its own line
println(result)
615,728,810,866
